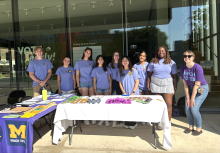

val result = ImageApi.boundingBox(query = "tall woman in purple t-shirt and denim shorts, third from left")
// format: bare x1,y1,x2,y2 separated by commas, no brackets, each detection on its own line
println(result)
74,47,95,125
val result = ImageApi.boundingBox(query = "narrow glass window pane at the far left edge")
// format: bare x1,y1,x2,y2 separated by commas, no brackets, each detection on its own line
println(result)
0,0,16,104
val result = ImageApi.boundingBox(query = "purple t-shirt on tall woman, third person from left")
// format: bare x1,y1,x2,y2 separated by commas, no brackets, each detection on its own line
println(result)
74,60,95,83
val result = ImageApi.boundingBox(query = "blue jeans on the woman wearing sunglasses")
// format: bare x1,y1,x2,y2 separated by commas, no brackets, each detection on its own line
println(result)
185,84,209,128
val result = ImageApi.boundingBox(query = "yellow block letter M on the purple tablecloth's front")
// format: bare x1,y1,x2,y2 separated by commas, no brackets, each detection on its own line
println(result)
8,124,26,139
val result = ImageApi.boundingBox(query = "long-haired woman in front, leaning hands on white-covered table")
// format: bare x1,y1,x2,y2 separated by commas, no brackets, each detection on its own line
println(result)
118,56,140,129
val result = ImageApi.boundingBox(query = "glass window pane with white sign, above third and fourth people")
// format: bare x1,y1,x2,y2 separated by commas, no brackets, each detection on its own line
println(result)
68,0,123,64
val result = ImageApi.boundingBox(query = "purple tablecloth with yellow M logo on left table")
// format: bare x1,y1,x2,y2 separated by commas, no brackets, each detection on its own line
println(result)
0,94,74,153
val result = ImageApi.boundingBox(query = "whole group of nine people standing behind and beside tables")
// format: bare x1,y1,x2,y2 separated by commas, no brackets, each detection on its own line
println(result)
27,46,209,135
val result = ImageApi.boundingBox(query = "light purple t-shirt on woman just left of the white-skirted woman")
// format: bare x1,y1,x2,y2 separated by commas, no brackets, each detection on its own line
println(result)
134,62,148,91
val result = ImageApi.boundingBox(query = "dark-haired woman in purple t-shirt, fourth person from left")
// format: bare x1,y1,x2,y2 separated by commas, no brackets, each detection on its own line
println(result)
91,55,112,126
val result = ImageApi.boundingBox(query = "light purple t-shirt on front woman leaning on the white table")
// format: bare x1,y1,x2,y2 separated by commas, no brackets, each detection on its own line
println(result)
117,68,140,95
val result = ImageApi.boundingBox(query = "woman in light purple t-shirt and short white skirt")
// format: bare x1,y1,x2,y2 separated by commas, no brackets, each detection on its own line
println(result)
147,46,177,129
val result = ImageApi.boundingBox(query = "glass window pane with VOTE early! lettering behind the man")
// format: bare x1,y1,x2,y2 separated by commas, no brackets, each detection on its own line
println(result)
17,0,67,96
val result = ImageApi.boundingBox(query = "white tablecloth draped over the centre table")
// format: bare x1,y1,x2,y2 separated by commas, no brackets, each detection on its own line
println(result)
53,95,172,150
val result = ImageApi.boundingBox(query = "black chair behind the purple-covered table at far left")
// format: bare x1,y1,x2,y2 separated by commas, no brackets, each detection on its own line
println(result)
7,90,26,105
